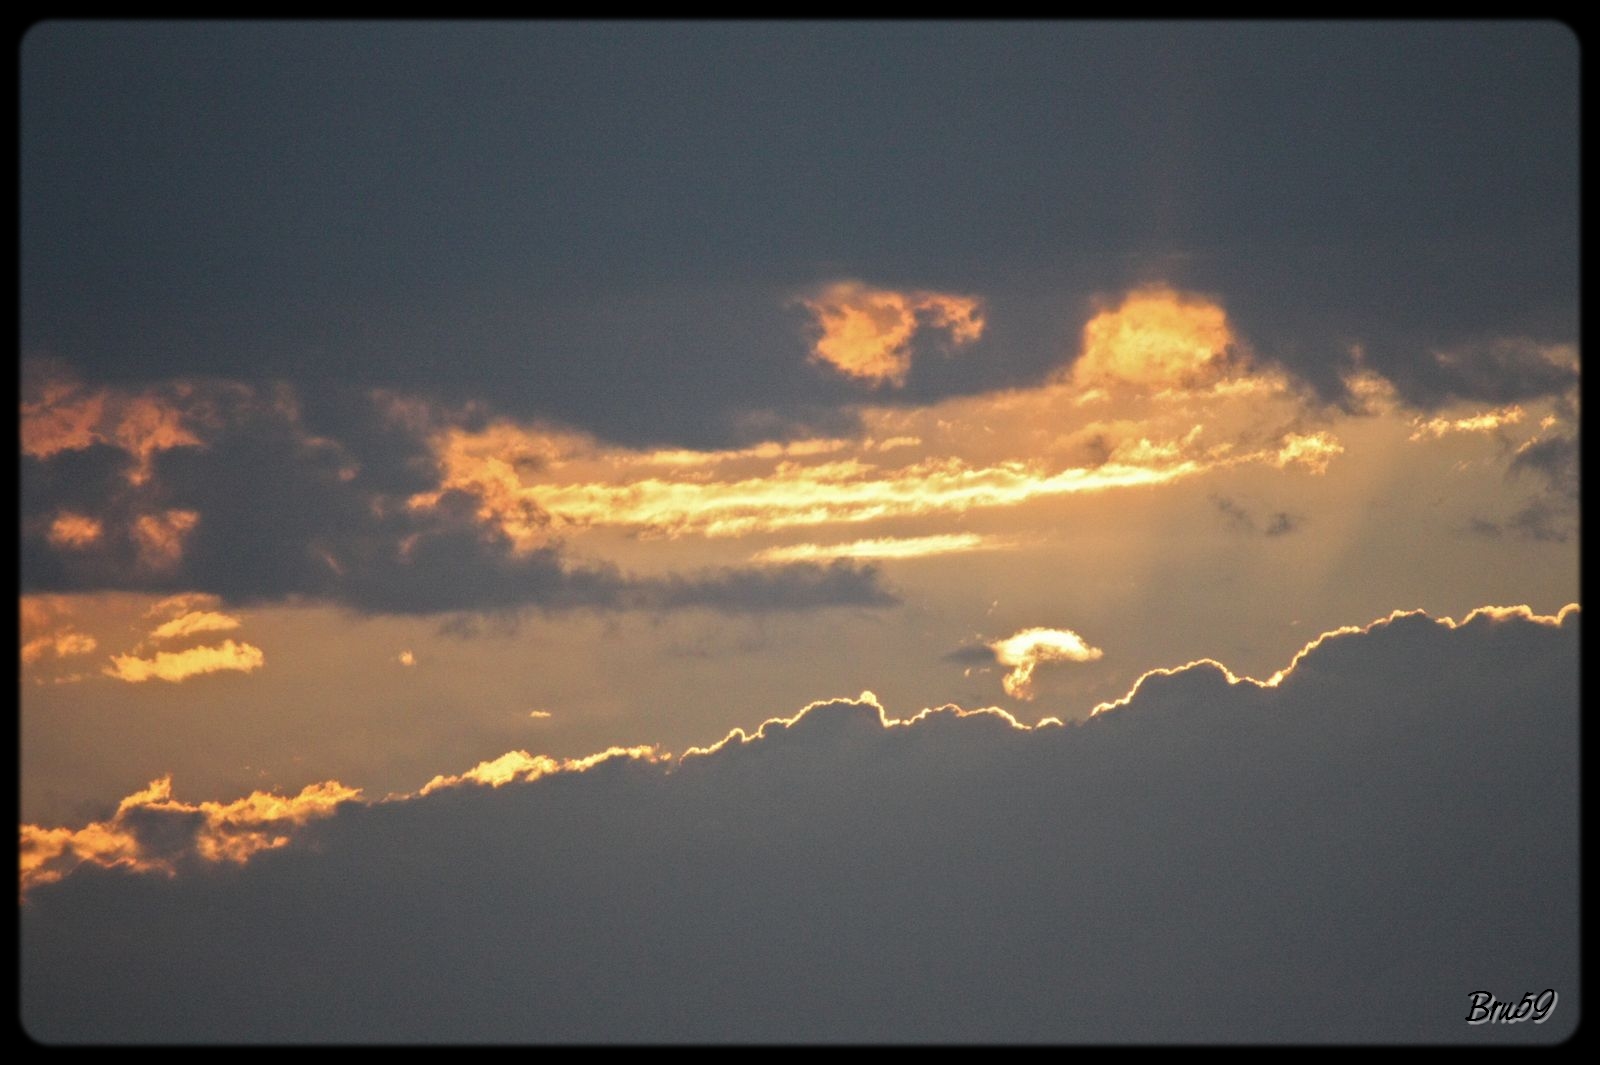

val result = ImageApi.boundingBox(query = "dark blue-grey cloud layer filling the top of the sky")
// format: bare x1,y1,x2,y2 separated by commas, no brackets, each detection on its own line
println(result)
21,22,1578,446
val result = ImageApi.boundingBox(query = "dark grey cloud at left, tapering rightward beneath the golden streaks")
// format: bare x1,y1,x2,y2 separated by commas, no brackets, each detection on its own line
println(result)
22,381,898,614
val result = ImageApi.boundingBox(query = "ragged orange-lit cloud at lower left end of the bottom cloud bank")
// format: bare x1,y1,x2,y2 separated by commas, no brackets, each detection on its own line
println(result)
19,777,360,892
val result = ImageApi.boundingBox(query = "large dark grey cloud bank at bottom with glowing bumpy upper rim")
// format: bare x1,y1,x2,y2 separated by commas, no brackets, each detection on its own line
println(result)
21,612,1582,1044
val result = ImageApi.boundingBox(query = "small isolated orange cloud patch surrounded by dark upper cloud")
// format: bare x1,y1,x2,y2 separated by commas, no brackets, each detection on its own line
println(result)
800,281,984,385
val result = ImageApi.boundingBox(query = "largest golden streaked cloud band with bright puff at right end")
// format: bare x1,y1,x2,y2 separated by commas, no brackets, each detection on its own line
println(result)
408,286,1344,561
